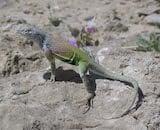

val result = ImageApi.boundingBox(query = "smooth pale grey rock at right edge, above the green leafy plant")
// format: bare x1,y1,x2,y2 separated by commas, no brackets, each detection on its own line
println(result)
144,14,160,25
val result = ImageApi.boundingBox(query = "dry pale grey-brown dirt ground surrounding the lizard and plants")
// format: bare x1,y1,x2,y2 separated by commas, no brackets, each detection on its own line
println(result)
0,0,160,130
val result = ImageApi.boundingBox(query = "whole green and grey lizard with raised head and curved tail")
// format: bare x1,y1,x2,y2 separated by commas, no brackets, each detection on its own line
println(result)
16,24,144,118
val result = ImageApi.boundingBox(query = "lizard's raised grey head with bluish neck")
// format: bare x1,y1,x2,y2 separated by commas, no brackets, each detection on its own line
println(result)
16,24,46,46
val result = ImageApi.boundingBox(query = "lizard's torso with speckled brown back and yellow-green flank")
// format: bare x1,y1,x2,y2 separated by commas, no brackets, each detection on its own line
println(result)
49,36,90,65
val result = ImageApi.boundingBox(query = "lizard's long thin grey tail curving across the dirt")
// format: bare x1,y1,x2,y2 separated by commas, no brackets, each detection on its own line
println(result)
89,62,143,119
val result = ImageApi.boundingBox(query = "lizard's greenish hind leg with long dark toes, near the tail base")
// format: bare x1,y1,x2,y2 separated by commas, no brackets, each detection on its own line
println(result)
78,62,96,114
